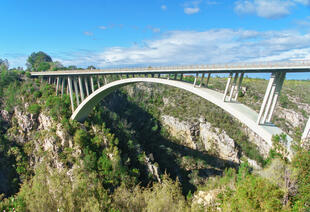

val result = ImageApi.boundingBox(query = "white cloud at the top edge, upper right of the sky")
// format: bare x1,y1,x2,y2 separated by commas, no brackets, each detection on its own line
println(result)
235,0,298,19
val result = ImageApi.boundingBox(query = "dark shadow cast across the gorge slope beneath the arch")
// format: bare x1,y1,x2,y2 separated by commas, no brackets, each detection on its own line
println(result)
89,91,238,195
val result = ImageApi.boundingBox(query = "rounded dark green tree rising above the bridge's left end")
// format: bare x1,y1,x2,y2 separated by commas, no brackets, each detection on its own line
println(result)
26,51,53,71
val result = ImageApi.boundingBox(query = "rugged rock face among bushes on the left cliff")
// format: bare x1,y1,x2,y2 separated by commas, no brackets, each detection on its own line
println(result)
8,107,76,173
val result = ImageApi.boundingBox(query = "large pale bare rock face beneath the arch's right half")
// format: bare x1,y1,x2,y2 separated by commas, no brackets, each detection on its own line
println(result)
161,115,240,163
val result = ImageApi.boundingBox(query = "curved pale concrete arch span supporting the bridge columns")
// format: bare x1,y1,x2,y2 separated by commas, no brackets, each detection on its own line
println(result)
71,78,290,146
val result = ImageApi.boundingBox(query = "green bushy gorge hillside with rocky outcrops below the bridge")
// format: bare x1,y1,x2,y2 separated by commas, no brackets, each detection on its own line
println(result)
0,71,310,211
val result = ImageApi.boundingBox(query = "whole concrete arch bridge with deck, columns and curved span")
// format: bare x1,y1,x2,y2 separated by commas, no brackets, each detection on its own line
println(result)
31,61,310,154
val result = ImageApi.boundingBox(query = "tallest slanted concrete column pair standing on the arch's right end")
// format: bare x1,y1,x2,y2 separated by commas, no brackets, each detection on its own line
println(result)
257,72,286,124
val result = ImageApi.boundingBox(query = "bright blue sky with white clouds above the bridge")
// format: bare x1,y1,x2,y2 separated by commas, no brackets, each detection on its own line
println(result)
0,0,310,72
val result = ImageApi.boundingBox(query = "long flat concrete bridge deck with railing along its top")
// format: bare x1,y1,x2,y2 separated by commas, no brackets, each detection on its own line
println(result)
31,62,310,76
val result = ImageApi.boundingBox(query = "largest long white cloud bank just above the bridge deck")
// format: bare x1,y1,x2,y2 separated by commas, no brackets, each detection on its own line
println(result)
58,29,310,67
